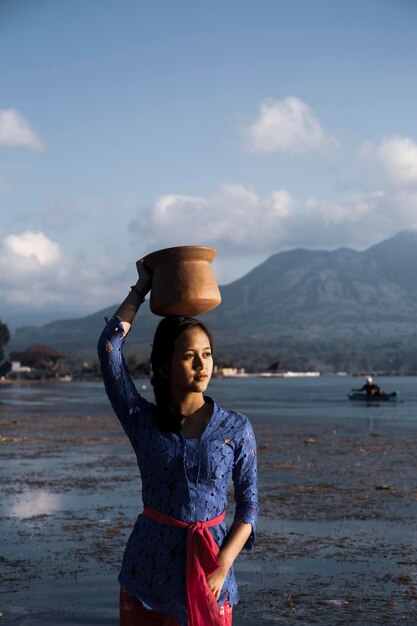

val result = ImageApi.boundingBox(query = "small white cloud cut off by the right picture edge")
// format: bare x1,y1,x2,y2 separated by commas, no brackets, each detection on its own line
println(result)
360,136,417,186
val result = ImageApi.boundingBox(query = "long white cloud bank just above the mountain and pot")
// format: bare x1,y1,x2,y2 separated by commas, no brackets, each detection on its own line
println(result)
131,178,417,266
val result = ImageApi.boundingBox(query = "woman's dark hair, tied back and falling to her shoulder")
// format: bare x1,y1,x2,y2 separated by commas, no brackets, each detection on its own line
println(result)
151,315,213,433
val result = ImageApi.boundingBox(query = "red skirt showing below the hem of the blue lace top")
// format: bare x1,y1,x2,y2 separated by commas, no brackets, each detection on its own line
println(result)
119,586,232,626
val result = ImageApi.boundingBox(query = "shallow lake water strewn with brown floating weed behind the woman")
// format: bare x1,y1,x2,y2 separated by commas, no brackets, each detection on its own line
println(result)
0,386,417,626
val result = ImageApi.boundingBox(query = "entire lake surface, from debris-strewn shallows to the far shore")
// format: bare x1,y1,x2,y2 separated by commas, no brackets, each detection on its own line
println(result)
0,376,417,626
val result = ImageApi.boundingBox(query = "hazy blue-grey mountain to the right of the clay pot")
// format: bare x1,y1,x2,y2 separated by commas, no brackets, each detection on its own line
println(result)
202,231,417,339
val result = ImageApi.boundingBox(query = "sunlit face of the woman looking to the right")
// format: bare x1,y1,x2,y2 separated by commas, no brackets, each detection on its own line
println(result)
168,326,213,393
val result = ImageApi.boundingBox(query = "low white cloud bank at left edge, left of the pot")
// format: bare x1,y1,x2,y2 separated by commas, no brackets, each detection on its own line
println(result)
0,231,127,316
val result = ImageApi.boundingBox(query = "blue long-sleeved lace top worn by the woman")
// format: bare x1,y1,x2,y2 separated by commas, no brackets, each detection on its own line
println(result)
98,317,258,626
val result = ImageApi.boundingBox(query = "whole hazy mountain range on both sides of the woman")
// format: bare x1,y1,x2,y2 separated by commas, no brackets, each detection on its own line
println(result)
11,231,417,367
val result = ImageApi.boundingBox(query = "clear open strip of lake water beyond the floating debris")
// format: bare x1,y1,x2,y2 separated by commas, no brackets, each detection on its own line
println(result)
0,376,417,423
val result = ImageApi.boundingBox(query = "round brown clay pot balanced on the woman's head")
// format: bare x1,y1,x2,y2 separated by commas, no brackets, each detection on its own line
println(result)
143,246,221,317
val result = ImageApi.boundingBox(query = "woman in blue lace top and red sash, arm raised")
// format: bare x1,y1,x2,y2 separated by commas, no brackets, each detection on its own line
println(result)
98,262,258,626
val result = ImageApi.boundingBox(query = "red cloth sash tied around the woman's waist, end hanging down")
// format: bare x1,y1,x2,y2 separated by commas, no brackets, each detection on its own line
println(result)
143,506,226,626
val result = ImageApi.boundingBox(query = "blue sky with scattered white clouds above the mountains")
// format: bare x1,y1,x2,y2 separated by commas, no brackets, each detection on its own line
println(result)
0,0,417,326
